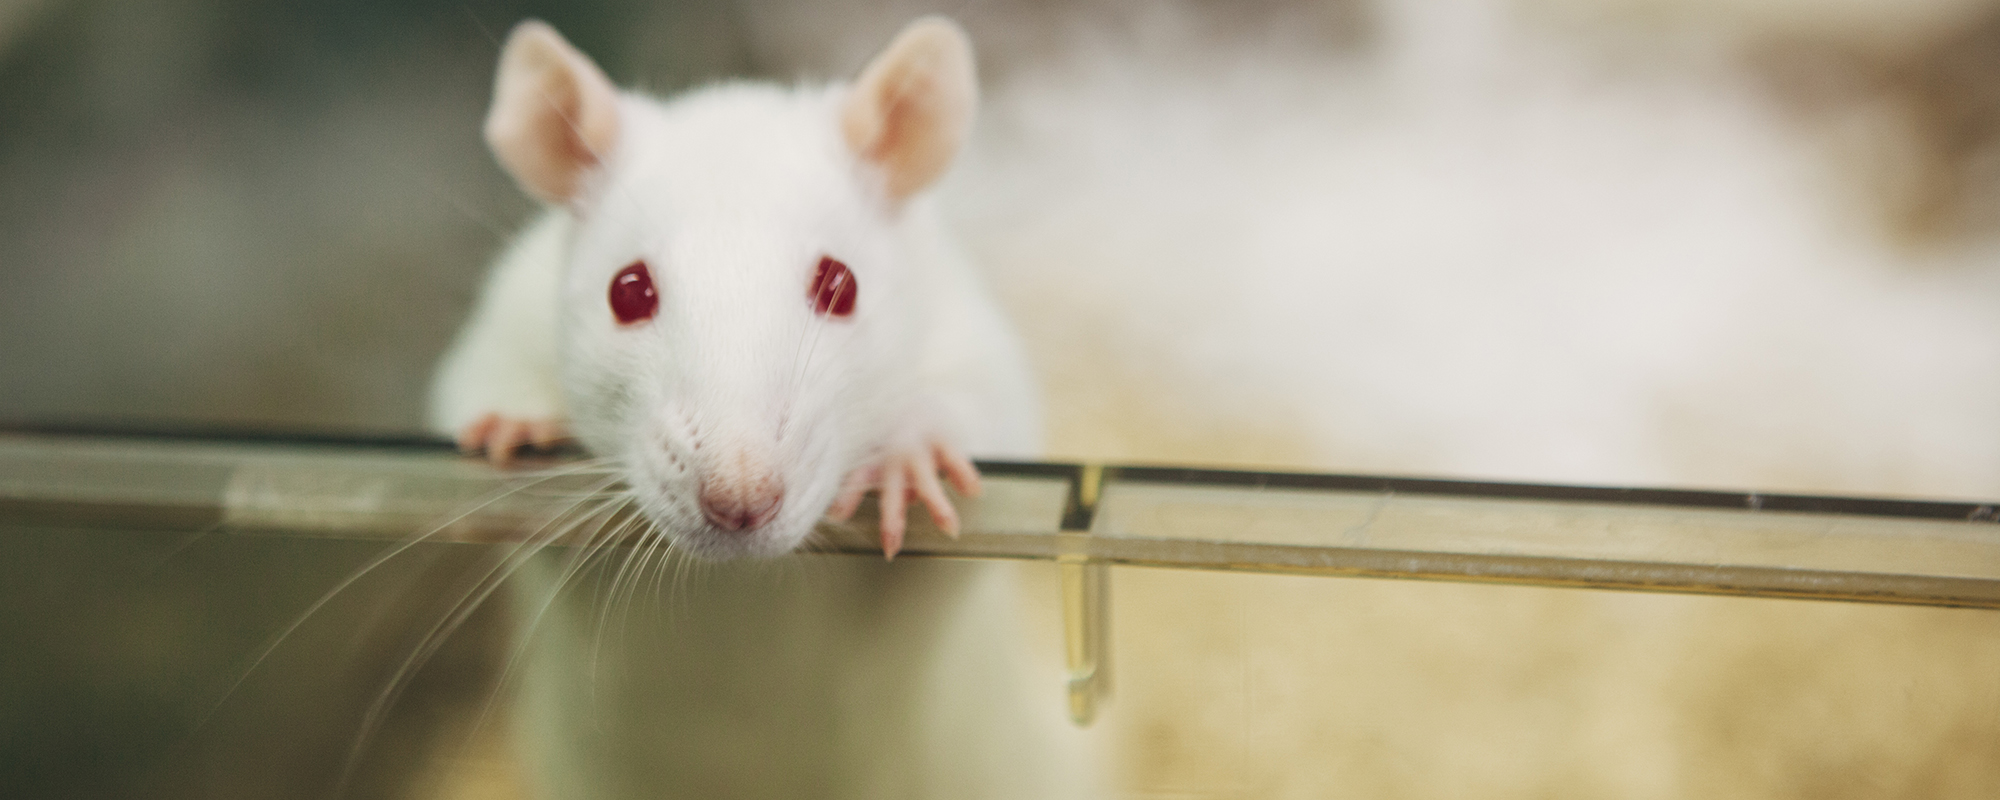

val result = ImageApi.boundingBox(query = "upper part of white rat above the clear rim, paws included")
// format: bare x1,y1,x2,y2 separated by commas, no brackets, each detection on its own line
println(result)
432,18,1040,556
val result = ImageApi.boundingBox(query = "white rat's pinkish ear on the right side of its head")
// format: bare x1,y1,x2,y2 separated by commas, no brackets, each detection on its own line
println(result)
840,16,980,200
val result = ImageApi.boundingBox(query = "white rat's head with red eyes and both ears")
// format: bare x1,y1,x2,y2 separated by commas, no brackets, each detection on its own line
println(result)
486,18,976,558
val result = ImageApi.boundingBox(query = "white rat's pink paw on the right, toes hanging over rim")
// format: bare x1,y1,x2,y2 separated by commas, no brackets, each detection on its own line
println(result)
826,442,980,558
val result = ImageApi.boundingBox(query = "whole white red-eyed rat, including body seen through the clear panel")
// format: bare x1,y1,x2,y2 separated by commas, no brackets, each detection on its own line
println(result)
432,18,1094,798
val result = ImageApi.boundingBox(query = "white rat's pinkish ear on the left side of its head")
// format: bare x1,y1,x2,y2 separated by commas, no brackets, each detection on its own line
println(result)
486,20,618,204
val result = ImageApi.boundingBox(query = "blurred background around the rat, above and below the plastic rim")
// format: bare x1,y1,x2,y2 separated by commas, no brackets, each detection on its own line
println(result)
11,0,2000,798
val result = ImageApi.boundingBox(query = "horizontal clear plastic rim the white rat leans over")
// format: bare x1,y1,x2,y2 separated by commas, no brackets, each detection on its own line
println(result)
15,434,2000,608
